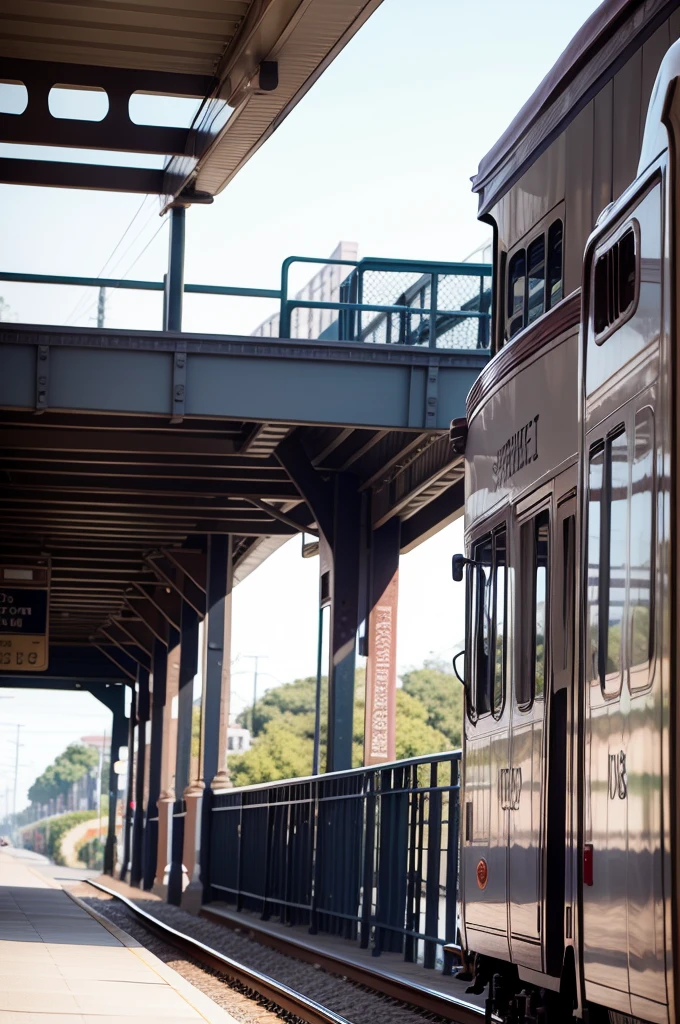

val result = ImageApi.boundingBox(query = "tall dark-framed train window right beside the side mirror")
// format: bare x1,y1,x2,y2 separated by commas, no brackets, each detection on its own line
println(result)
465,520,509,725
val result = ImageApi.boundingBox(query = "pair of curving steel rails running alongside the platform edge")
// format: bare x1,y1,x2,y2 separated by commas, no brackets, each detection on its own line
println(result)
83,879,483,1024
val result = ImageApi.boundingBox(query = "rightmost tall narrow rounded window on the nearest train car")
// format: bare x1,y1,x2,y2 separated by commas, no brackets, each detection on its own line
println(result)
629,408,654,688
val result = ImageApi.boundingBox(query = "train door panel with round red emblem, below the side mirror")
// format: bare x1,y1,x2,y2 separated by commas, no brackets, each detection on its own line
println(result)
462,521,510,958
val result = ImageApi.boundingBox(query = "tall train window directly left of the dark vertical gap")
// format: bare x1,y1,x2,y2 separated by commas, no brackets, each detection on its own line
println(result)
513,499,554,715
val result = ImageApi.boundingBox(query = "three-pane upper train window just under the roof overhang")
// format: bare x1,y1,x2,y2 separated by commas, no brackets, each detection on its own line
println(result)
503,213,561,345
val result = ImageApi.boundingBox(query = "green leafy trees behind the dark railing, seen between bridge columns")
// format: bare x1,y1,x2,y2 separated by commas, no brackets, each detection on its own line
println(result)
228,667,461,786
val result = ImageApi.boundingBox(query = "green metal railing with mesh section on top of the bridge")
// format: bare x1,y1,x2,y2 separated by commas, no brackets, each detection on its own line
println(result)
0,256,492,349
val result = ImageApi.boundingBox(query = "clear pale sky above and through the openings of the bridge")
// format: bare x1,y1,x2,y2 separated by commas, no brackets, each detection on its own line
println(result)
0,0,598,816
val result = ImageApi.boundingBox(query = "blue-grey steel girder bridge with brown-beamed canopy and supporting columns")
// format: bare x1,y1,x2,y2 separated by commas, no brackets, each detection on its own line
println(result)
0,0,491,900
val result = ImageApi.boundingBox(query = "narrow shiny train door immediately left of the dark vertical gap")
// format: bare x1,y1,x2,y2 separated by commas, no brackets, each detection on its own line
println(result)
506,488,552,971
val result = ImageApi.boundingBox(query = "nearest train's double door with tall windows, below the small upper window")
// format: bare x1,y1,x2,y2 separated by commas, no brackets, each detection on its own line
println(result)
584,388,666,1020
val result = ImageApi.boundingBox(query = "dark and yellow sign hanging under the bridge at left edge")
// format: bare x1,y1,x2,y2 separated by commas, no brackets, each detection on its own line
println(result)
0,558,50,672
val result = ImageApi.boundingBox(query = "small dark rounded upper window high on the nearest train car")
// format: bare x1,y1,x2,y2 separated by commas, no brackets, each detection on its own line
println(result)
590,218,648,345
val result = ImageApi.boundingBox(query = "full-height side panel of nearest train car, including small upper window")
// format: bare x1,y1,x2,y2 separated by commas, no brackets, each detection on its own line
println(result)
583,175,669,1021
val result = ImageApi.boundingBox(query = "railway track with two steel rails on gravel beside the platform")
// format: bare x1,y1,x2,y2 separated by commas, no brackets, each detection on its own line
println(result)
87,879,483,1024
